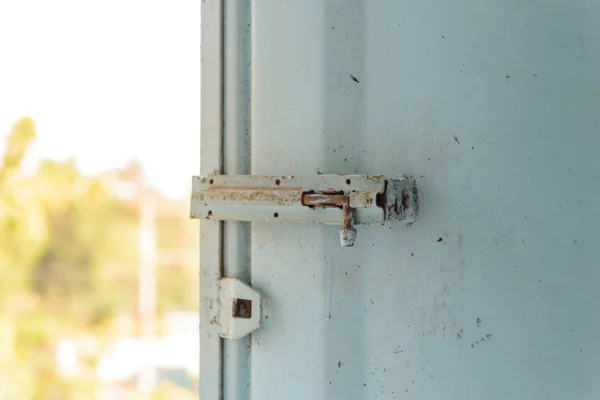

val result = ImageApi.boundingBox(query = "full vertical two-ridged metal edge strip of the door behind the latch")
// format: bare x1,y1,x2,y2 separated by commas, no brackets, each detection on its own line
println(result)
199,0,252,400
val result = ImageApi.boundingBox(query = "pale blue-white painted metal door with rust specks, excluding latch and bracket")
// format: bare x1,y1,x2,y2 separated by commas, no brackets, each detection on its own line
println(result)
200,0,600,400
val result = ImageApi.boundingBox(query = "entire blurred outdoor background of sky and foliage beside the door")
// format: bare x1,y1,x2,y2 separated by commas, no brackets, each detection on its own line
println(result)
0,0,200,400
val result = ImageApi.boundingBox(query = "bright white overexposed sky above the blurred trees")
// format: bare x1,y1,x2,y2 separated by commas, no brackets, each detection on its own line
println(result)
0,0,200,197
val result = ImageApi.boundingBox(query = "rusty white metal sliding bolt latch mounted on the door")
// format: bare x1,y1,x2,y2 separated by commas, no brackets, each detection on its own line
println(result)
191,175,419,247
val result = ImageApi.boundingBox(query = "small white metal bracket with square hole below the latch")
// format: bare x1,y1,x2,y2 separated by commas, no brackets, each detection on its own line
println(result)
212,278,263,339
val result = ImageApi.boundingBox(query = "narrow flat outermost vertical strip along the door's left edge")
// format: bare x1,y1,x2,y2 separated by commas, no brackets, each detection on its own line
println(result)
199,0,223,399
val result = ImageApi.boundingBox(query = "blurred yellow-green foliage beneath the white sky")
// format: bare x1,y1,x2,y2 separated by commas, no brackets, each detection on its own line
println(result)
0,118,197,400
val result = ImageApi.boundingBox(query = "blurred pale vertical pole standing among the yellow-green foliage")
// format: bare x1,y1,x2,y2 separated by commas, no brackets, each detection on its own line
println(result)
138,177,157,395
